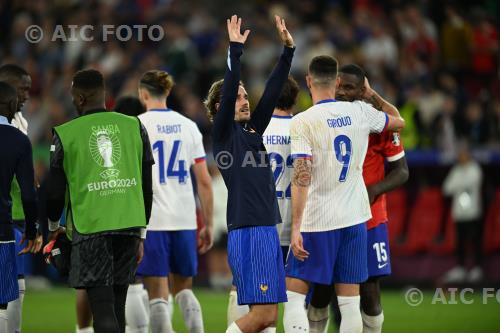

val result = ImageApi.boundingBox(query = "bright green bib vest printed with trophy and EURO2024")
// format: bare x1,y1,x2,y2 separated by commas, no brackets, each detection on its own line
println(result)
54,112,146,234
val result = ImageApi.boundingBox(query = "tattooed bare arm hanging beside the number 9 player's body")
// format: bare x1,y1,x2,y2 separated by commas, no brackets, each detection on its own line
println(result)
290,158,312,260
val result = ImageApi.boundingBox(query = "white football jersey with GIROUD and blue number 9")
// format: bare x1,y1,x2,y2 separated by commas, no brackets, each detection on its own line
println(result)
290,100,388,232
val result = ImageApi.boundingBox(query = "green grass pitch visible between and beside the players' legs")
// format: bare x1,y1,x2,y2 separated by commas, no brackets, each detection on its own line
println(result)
23,288,500,333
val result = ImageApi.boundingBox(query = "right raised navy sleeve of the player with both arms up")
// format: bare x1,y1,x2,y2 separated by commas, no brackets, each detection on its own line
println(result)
252,46,295,134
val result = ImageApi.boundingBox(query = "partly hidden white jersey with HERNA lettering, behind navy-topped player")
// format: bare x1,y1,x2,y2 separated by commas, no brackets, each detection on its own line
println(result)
262,116,293,246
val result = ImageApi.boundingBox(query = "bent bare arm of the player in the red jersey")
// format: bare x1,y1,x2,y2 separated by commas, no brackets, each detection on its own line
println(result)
366,156,410,204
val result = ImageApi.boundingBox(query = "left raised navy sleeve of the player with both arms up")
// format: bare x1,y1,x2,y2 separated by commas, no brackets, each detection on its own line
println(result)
213,42,243,140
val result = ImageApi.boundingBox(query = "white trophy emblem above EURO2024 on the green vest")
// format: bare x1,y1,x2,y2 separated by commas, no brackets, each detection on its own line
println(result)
89,125,122,179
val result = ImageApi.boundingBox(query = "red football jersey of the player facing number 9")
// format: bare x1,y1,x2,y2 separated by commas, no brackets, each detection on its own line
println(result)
363,131,404,229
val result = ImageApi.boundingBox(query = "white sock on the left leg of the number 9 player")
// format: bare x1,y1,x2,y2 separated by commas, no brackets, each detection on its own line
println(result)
283,290,309,333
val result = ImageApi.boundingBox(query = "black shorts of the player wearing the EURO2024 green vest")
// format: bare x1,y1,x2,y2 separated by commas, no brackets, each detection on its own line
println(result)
69,235,140,289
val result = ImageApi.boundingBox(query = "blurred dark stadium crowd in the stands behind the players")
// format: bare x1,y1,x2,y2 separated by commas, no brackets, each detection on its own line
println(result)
0,0,500,284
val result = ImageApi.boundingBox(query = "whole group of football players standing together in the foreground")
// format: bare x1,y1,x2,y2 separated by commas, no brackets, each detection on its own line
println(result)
0,16,408,333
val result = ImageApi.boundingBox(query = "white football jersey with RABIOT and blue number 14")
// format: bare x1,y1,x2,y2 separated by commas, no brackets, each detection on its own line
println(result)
139,109,206,230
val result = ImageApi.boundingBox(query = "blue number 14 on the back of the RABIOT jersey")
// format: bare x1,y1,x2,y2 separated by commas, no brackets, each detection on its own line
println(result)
153,140,188,184
